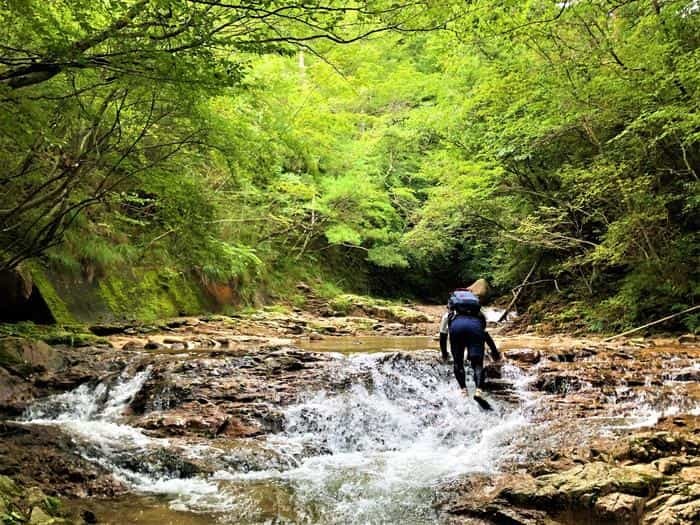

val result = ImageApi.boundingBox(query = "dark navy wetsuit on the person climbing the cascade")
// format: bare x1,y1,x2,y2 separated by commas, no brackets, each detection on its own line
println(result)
450,314,501,388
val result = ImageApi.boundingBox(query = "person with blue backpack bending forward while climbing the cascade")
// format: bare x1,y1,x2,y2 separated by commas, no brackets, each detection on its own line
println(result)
440,290,501,399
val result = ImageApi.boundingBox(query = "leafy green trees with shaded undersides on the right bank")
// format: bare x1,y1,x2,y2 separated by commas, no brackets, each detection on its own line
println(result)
409,1,700,328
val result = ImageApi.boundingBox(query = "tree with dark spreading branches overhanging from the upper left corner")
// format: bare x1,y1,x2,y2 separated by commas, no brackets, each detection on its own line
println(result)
0,0,446,270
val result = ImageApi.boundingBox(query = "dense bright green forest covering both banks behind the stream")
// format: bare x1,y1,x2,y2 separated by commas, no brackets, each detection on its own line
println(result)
0,0,700,331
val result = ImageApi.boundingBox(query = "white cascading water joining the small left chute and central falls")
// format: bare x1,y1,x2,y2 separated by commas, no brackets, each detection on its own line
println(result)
25,354,525,523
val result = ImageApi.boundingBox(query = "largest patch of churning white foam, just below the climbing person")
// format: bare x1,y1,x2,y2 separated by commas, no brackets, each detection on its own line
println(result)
205,354,526,523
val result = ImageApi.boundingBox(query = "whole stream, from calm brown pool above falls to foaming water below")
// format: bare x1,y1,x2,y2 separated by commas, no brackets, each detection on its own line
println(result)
16,337,697,525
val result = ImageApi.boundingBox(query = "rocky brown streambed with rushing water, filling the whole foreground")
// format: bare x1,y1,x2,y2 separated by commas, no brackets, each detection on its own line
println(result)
0,312,700,525
